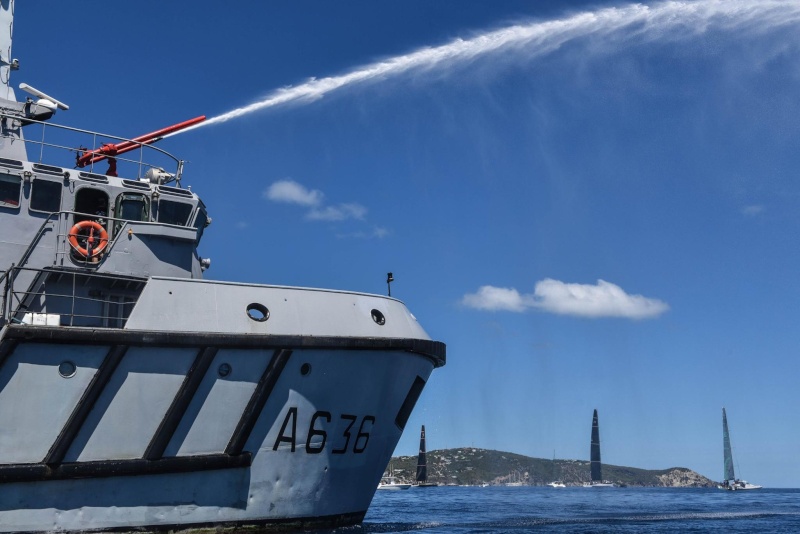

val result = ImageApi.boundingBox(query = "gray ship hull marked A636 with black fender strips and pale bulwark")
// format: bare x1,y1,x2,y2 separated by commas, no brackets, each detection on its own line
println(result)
0,279,444,532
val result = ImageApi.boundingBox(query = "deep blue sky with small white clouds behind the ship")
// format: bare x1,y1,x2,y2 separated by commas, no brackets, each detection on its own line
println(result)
13,0,800,486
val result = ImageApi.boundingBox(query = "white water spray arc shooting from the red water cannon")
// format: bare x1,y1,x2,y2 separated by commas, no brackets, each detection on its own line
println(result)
171,0,800,135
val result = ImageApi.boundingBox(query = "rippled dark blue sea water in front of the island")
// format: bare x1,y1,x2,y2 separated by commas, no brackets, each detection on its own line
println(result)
335,486,800,533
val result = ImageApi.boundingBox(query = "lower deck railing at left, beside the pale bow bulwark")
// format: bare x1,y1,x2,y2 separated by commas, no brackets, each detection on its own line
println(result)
0,267,146,328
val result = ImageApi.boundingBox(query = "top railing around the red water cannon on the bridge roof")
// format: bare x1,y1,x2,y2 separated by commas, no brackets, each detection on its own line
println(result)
0,110,183,181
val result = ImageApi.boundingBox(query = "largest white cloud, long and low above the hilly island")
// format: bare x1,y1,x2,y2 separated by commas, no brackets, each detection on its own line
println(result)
461,278,669,319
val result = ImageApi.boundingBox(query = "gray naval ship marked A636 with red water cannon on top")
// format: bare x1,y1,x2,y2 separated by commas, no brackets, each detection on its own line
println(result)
0,0,445,532
